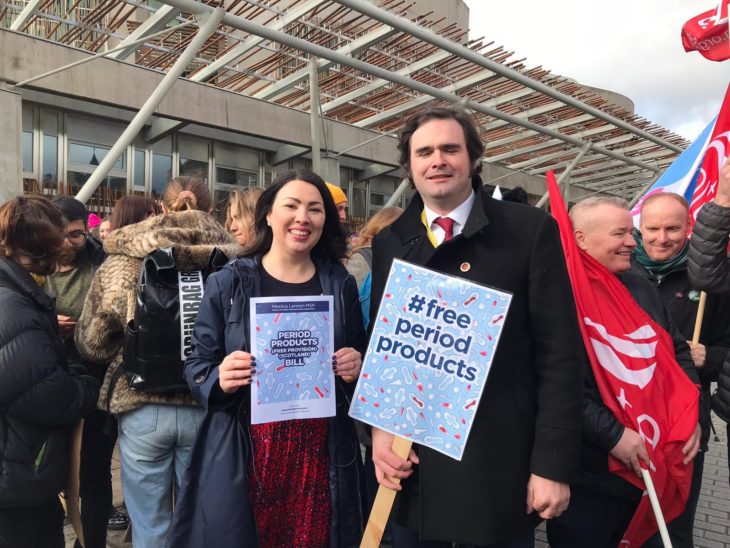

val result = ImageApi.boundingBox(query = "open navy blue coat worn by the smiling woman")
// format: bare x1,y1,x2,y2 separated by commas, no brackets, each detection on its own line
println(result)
167,257,366,548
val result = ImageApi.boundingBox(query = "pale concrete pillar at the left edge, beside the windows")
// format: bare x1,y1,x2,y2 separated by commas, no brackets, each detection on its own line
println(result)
0,82,23,203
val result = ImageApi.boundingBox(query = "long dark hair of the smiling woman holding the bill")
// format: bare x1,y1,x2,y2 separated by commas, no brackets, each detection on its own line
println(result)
246,169,347,261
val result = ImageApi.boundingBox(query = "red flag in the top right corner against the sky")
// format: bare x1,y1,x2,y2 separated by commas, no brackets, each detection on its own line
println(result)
682,0,730,61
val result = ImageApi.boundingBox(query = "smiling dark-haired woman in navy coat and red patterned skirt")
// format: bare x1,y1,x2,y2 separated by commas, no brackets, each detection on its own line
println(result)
167,169,365,548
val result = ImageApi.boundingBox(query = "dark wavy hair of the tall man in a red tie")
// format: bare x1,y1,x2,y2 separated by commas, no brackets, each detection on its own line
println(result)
398,107,485,182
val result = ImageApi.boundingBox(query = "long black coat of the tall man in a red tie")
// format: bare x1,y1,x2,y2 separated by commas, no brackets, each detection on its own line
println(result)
370,178,584,545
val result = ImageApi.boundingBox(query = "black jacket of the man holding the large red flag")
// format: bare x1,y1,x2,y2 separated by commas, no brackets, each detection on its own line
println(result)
575,272,699,499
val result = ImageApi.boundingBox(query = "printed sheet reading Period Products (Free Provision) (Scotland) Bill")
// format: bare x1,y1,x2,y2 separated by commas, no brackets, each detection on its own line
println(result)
251,296,335,424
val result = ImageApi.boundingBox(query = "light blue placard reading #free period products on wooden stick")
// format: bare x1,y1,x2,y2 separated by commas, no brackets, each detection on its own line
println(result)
350,259,512,460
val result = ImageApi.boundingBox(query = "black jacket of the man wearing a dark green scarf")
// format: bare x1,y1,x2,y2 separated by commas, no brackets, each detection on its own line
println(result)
631,257,730,451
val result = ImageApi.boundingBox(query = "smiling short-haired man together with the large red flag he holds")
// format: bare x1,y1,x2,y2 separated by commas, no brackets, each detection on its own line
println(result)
547,185,700,548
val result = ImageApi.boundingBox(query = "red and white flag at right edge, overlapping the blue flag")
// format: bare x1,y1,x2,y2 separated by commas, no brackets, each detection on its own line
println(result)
689,84,730,220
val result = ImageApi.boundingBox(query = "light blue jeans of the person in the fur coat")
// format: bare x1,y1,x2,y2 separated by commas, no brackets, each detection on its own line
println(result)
119,404,204,548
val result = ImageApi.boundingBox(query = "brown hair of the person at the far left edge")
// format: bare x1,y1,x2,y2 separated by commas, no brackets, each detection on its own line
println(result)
0,196,66,276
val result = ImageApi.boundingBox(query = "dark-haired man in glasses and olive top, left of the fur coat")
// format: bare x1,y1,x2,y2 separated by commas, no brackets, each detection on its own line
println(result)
45,196,116,548
